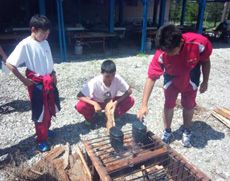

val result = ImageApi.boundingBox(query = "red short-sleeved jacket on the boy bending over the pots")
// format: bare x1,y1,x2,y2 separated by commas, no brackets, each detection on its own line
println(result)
148,33,212,91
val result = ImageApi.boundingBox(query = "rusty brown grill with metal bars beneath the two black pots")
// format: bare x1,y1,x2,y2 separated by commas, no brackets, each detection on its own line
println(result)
83,130,210,181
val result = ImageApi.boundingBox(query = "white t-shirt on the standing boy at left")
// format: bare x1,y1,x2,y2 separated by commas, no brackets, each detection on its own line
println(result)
6,36,53,76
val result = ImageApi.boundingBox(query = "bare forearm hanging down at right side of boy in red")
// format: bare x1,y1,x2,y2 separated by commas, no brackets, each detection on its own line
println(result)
200,60,211,93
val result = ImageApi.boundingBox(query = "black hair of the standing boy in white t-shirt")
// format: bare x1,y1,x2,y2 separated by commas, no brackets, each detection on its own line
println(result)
30,15,51,31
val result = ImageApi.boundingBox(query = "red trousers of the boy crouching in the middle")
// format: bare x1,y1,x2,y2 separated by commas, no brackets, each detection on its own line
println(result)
75,96,134,121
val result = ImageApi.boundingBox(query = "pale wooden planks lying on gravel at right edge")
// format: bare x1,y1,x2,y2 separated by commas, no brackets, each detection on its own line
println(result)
212,108,230,128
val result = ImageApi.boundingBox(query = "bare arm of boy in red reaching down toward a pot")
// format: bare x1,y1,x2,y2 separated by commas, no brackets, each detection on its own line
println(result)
137,78,156,120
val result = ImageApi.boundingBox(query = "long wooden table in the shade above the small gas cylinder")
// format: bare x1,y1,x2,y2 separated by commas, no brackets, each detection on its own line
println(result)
72,32,116,51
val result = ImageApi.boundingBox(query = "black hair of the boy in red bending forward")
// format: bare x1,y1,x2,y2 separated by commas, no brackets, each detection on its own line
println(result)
155,24,182,51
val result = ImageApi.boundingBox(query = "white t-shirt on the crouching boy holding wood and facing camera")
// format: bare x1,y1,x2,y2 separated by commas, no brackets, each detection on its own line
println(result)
81,74,129,102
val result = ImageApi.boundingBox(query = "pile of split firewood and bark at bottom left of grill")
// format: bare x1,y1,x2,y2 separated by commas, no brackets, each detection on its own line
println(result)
25,144,92,181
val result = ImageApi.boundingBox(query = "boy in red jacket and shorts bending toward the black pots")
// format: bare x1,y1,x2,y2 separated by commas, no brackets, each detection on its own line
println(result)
137,25,212,147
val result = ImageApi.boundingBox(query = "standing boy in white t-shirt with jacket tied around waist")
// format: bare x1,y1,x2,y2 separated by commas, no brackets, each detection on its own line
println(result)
6,15,60,152
